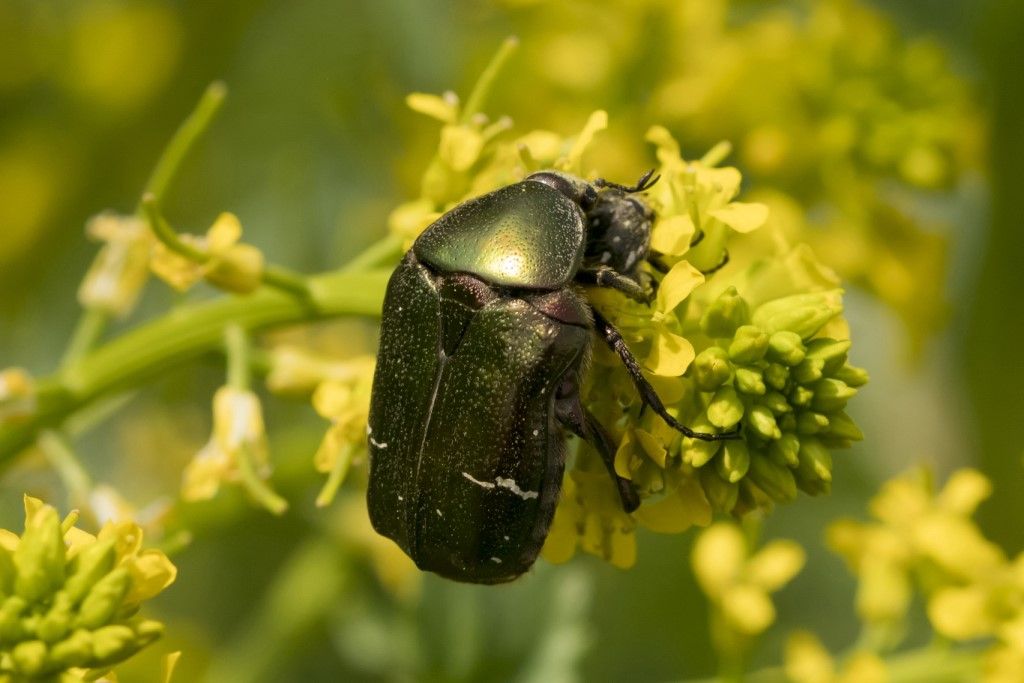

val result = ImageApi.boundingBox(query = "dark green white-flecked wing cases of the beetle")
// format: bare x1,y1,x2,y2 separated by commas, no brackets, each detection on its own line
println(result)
368,255,590,583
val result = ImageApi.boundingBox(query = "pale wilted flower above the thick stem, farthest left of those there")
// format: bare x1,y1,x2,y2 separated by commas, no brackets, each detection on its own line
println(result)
78,212,155,317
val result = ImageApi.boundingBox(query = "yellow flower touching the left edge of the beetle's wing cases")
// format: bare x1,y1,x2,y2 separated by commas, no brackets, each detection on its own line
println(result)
313,356,374,506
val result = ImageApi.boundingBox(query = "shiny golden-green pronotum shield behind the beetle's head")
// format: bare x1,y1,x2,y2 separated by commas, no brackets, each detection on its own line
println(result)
413,180,586,290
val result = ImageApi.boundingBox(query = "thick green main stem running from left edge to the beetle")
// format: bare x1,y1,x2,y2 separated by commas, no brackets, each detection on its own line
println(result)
0,269,390,466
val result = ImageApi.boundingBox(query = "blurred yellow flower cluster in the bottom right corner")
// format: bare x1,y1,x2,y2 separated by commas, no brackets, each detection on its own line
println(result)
828,469,1024,681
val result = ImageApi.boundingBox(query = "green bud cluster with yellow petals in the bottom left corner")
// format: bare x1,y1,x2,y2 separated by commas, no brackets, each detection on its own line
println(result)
0,497,176,681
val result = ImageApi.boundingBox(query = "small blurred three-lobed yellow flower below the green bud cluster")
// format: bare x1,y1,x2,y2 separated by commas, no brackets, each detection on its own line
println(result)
691,522,805,636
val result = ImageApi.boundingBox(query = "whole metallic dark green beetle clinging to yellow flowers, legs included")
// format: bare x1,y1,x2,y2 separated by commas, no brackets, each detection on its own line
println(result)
367,171,735,584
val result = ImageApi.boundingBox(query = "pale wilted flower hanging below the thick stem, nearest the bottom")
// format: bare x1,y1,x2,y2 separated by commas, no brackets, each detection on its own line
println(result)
181,386,288,514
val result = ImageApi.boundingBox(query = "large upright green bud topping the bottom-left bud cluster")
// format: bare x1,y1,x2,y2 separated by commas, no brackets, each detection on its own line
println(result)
13,507,65,602
